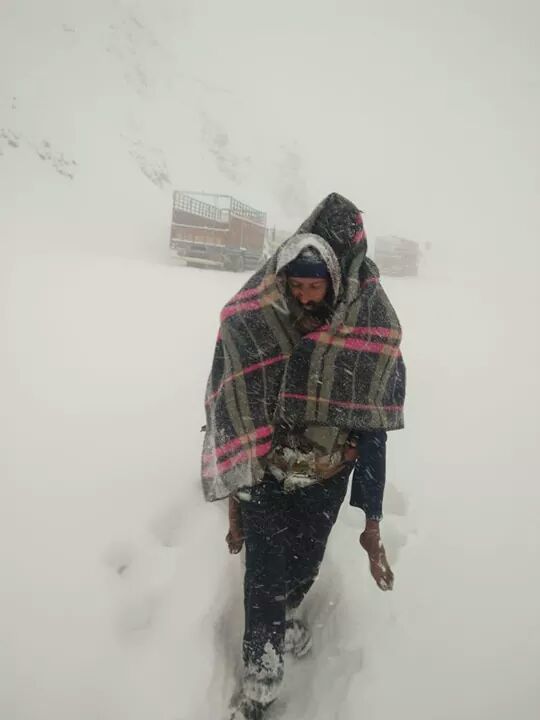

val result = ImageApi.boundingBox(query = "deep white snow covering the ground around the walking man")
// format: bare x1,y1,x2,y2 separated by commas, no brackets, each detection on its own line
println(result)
2,246,540,720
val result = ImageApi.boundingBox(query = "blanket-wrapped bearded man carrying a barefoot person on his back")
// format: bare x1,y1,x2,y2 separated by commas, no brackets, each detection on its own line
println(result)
202,193,405,720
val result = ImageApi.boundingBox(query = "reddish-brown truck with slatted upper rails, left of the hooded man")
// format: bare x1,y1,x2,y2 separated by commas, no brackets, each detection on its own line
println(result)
170,190,266,272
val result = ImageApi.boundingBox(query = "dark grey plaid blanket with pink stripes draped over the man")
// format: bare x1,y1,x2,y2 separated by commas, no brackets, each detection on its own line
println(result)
202,193,405,500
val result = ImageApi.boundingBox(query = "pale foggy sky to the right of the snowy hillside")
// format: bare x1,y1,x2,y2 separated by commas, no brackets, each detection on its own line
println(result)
167,0,540,258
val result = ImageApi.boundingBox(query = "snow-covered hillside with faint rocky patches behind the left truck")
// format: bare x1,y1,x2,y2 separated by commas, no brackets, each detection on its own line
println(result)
0,0,314,268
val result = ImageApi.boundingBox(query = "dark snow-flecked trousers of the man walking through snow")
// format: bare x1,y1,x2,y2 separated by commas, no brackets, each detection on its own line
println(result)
237,466,352,702
